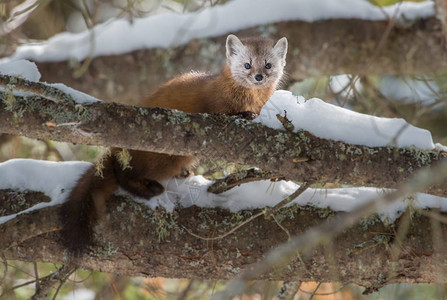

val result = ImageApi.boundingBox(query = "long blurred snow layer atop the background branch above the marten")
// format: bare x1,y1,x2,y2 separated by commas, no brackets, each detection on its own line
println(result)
0,0,434,61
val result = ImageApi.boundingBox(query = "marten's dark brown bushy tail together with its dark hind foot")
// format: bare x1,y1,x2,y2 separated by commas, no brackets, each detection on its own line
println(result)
60,154,164,257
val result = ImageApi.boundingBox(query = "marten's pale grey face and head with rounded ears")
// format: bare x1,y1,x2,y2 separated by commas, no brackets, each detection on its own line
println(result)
226,34,287,89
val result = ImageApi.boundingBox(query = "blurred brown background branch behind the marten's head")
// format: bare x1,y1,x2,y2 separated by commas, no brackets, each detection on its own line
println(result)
37,18,447,103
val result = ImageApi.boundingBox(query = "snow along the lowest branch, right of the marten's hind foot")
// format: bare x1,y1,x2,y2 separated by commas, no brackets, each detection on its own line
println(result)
147,176,447,222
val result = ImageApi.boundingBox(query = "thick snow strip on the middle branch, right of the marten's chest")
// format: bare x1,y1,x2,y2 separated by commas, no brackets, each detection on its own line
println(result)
254,91,435,150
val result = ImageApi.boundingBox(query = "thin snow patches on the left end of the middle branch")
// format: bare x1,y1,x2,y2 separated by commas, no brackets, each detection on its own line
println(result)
0,59,100,104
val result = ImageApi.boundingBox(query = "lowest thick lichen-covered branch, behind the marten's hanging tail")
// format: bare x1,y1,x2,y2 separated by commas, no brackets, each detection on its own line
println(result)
0,193,447,290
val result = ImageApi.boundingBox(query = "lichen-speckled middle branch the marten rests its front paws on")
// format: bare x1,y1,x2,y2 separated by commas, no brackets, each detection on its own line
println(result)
0,85,447,196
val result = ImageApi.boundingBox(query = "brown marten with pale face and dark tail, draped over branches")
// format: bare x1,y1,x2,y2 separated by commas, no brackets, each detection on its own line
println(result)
61,34,287,256
